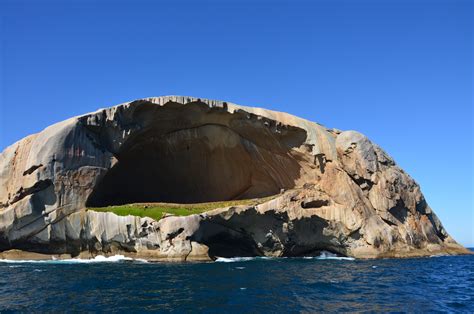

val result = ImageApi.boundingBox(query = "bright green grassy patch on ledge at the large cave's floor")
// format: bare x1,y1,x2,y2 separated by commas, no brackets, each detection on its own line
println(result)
87,195,276,220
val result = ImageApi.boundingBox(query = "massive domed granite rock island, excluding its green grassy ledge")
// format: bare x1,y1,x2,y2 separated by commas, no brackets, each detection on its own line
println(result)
0,96,467,261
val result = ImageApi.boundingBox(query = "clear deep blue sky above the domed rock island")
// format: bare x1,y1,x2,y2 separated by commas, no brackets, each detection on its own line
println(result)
0,0,474,246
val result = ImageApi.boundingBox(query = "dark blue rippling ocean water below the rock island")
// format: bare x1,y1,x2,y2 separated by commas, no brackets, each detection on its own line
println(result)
0,250,474,312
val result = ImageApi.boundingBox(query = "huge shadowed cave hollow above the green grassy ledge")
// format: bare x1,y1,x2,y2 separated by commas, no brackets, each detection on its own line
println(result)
86,102,305,207
